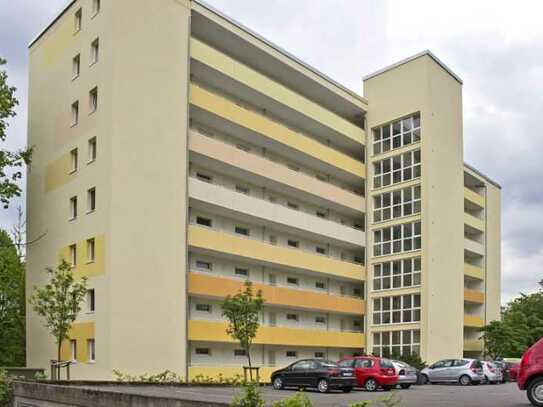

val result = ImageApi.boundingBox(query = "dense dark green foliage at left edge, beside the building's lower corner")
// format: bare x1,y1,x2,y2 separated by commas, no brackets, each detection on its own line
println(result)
0,230,26,366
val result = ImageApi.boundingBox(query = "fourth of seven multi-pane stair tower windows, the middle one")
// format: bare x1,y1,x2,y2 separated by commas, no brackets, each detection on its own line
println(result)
373,222,421,256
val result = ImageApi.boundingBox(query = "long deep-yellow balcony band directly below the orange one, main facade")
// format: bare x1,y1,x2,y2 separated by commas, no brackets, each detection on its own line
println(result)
188,320,365,349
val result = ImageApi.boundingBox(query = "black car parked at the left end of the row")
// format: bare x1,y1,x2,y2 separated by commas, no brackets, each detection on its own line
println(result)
271,359,356,393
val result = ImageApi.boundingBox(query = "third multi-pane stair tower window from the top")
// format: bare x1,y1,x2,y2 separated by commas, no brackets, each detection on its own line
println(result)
373,185,421,222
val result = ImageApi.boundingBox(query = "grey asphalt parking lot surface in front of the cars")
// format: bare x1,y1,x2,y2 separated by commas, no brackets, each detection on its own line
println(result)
83,383,530,407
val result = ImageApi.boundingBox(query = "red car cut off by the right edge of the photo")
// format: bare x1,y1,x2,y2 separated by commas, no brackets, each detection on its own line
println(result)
517,338,543,407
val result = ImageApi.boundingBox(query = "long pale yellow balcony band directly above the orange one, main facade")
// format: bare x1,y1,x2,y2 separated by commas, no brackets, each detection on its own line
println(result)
188,225,366,281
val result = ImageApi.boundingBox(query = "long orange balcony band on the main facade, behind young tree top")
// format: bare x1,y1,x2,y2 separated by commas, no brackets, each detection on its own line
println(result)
188,272,365,315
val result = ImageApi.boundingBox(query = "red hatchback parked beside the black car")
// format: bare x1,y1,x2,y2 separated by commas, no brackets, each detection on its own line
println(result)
338,356,398,391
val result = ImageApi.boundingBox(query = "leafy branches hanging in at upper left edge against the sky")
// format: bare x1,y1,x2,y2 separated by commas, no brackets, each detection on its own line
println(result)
0,58,32,208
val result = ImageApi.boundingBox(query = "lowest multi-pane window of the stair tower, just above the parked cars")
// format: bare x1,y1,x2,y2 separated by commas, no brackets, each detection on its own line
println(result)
372,329,420,357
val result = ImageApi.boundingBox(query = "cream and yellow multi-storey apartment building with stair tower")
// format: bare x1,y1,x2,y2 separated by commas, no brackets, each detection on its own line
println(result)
27,0,501,379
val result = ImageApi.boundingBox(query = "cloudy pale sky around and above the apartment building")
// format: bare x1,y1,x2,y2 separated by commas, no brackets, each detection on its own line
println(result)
0,0,543,303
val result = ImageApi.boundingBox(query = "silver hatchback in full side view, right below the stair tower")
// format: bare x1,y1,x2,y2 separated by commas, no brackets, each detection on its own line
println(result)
421,359,484,386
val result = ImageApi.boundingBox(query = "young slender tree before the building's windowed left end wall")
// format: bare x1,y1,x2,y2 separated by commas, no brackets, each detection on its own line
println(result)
30,260,87,361
